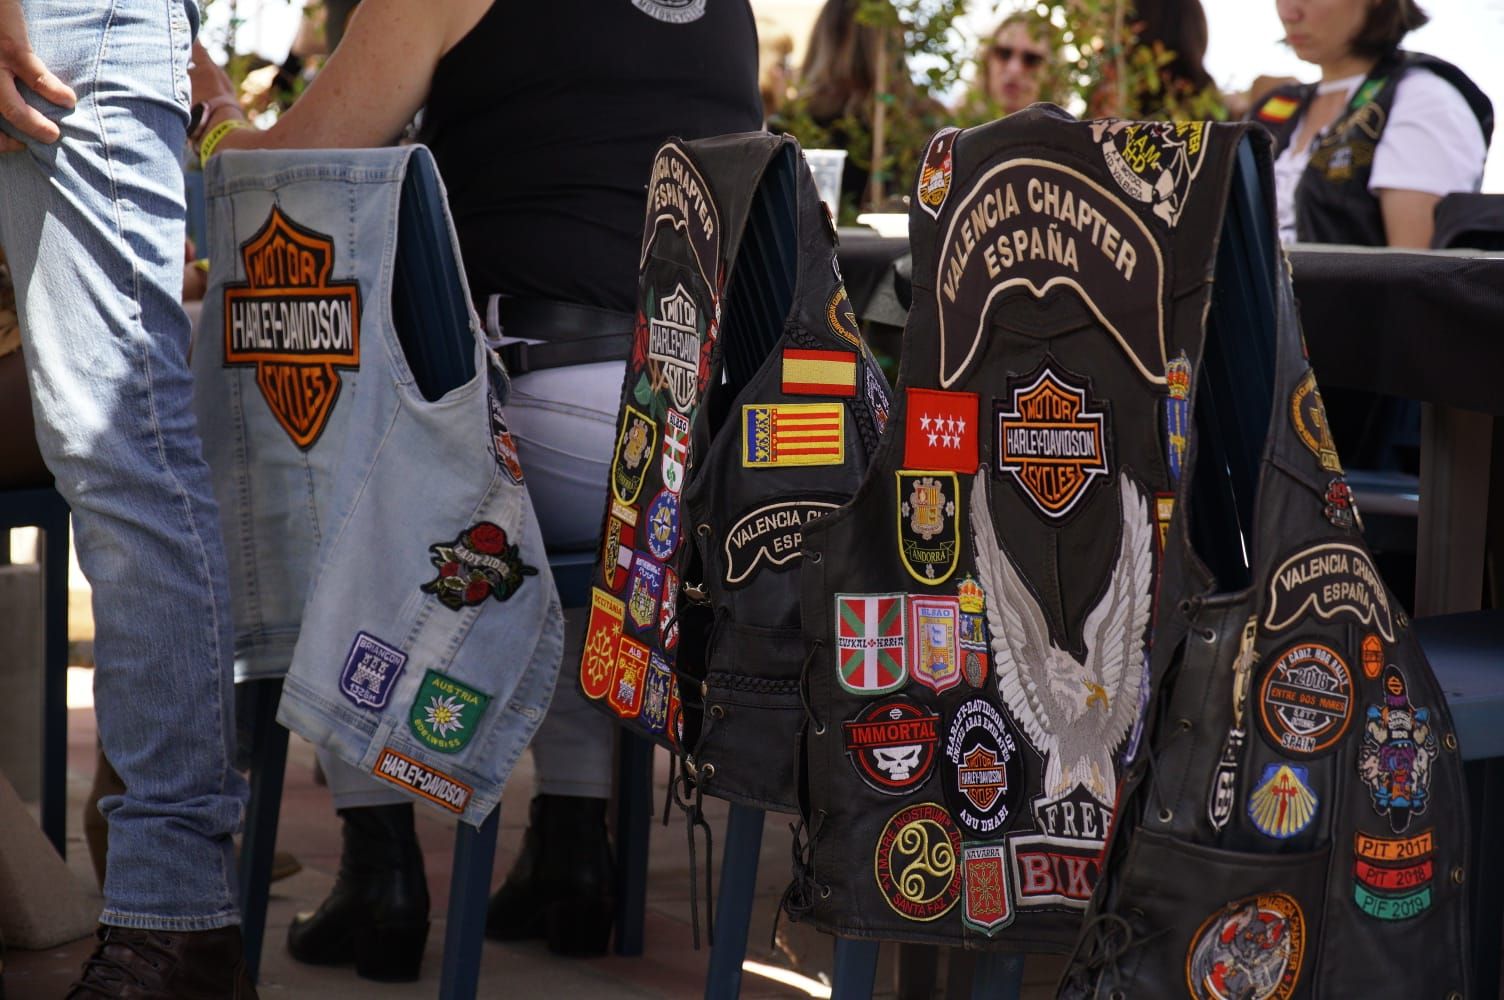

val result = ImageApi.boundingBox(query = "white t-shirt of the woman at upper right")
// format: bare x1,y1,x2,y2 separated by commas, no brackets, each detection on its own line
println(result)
1274,69,1487,244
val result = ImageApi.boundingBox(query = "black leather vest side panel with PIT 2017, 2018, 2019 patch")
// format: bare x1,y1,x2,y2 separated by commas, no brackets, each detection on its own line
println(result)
1060,126,1468,1000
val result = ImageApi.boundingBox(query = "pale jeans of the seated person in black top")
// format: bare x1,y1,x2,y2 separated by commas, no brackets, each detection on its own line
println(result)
319,354,624,809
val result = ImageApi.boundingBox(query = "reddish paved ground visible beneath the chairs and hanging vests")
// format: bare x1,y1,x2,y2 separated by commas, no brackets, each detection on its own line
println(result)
5,694,1059,1000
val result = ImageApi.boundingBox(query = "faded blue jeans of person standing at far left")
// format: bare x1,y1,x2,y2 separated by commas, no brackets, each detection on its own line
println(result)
0,0,245,931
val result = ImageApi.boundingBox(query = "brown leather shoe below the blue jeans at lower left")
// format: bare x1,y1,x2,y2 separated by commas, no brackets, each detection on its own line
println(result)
68,926,256,1000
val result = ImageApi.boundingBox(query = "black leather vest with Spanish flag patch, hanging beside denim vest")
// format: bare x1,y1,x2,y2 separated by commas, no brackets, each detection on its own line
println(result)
579,134,889,812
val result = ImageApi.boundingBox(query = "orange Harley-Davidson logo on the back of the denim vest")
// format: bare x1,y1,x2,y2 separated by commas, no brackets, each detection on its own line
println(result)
224,206,361,451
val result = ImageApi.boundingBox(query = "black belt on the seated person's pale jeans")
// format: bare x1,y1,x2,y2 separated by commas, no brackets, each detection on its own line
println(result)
496,296,635,374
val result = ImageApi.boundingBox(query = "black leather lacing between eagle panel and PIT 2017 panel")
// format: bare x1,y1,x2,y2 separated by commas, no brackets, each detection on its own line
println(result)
1059,597,1202,1000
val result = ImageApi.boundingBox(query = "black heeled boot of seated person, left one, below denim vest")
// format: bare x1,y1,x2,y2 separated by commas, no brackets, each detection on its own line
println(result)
287,805,429,982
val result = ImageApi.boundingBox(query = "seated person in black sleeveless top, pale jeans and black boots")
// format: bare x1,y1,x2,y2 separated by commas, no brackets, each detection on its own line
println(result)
194,0,763,976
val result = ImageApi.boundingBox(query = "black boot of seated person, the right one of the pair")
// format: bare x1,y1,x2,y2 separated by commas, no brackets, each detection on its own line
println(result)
486,795,617,956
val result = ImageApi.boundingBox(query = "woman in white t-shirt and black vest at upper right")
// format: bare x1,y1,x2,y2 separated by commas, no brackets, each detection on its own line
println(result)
1253,0,1493,248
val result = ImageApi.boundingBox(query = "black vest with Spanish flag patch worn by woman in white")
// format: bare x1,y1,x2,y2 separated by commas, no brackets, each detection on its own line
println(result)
1250,51,1493,247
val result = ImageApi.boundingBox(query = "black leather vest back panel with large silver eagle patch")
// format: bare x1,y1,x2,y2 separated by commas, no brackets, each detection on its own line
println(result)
790,105,1232,952
